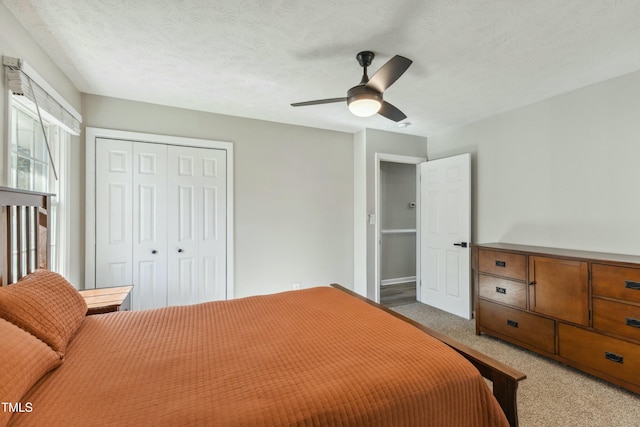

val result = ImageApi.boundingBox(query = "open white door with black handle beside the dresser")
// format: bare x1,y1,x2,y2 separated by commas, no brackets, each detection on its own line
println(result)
419,154,472,319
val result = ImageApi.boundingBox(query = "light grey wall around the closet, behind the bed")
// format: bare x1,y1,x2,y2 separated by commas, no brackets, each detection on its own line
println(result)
82,94,354,297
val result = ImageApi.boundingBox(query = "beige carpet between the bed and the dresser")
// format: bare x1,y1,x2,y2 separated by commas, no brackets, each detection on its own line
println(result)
393,303,640,427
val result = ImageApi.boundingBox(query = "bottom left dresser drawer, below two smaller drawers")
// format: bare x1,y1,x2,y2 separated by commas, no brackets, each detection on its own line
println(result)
478,300,555,353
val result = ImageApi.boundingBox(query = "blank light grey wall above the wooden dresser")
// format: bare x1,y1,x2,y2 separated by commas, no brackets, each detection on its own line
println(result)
428,72,640,255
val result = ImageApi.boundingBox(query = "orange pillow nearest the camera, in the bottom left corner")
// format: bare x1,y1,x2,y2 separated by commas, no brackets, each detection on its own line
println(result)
0,319,62,426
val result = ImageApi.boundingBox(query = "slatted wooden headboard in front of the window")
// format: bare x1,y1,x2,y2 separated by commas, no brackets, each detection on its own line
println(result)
0,187,53,286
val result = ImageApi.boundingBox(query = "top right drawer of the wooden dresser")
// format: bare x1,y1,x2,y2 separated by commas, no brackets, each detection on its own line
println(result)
591,264,640,303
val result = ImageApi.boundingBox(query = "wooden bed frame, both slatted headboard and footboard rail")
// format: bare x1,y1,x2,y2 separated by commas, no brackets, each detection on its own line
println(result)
0,187,526,427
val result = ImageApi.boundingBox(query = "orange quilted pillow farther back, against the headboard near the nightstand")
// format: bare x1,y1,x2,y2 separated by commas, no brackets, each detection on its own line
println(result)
0,270,87,357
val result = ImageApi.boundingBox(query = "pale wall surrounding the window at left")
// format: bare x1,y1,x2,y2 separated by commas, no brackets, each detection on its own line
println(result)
0,4,84,287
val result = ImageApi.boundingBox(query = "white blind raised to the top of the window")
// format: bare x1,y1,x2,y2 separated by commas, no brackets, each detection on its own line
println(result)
3,56,82,135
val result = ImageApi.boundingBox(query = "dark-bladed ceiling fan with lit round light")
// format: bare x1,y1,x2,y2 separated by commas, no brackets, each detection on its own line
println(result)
291,50,413,122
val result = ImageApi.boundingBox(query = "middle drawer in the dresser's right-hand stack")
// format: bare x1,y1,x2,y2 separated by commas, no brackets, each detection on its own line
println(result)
593,298,640,341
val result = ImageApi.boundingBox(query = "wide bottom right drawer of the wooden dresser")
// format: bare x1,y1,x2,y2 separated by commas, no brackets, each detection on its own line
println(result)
558,323,640,384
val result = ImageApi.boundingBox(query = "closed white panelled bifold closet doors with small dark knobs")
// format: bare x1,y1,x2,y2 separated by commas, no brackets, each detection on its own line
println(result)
96,139,227,309
